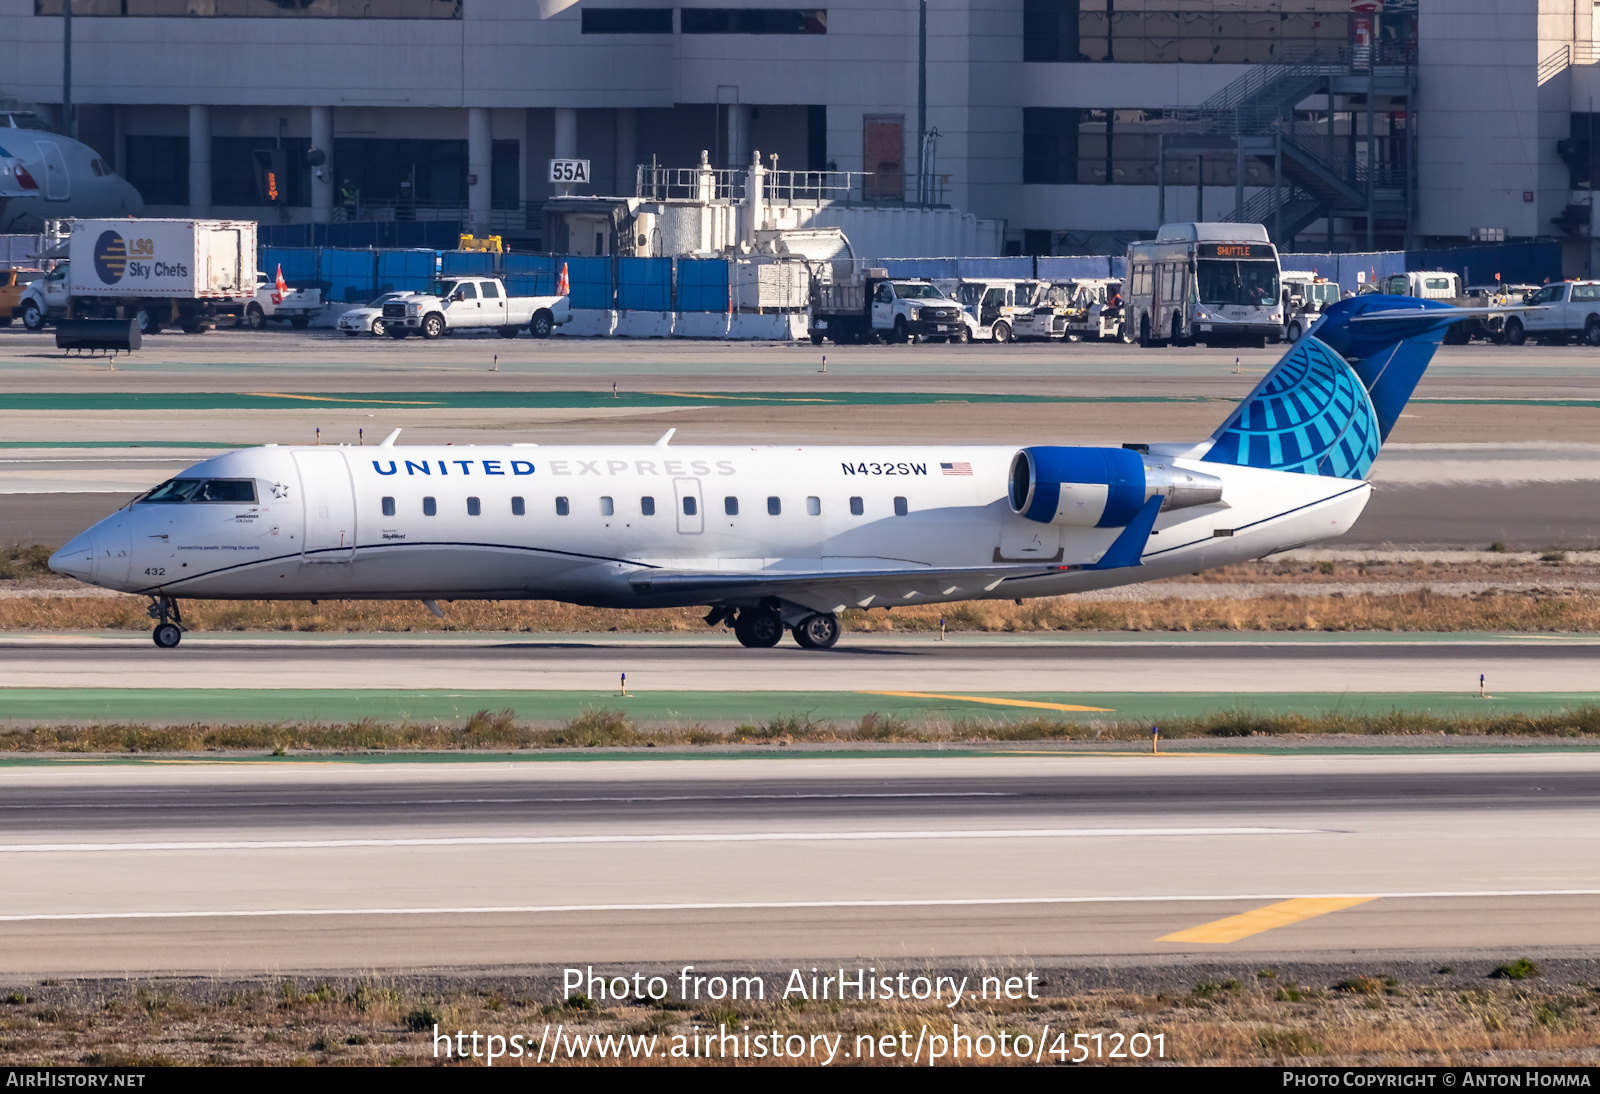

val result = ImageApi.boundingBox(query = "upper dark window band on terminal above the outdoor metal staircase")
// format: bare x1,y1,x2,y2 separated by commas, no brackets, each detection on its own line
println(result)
1022,0,1369,64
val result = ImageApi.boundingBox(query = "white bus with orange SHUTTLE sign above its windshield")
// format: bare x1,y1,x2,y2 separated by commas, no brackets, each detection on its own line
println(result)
1122,224,1283,345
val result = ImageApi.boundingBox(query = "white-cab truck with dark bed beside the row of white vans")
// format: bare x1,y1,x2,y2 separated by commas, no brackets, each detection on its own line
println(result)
810,267,968,345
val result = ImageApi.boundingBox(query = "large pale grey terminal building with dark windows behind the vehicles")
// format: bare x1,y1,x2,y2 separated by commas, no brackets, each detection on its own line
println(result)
0,0,1600,262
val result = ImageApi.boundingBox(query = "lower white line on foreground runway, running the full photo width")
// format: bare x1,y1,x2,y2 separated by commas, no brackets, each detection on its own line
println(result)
0,889,1600,923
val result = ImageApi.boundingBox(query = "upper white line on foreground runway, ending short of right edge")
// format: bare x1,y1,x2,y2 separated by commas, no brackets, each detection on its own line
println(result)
0,828,1318,854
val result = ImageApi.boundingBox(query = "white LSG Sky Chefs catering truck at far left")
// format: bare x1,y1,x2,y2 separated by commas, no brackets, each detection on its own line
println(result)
21,218,256,334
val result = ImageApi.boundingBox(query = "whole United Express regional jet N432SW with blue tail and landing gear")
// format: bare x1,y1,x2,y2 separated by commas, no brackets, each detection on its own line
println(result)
50,294,1462,649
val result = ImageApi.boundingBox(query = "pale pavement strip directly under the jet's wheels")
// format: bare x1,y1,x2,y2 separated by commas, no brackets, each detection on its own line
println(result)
0,632,1600,690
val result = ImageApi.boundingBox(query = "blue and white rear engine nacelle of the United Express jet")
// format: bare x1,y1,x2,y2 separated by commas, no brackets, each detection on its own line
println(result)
1010,446,1222,528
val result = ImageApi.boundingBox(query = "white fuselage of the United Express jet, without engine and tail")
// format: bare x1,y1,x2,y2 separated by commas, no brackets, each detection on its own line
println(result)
51,445,1371,611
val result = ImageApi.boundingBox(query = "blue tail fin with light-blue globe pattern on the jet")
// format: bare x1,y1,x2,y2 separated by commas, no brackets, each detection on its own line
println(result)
1202,294,1461,478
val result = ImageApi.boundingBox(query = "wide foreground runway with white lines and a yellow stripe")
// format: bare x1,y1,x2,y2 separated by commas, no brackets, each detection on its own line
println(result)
0,752,1600,976
